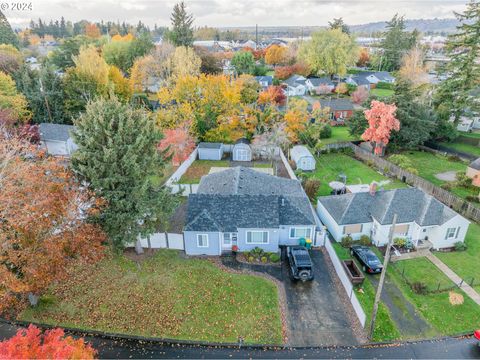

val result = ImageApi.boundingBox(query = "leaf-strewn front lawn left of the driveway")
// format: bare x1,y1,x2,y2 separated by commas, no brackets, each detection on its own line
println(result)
20,250,283,344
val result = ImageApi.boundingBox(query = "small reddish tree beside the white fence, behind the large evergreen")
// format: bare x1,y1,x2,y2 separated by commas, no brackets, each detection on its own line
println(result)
158,129,195,166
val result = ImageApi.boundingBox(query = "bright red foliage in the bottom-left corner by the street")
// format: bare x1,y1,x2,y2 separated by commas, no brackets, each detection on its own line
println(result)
0,325,97,359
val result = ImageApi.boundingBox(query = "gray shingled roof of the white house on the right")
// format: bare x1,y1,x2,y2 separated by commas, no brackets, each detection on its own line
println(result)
318,188,457,226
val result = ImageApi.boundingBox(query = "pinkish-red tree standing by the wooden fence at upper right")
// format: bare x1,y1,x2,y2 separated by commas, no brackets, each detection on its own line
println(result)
362,100,400,155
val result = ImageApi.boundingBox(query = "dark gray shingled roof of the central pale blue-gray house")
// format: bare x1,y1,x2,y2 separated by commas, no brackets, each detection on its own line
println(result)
185,167,315,232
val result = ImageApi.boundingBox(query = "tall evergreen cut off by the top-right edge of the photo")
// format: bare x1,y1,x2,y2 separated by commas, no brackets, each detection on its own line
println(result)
435,1,480,122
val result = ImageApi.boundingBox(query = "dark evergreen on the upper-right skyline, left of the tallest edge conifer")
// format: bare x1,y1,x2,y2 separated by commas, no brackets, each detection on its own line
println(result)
379,14,419,71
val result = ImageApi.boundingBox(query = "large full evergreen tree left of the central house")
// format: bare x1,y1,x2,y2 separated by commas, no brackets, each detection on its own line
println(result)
72,98,177,249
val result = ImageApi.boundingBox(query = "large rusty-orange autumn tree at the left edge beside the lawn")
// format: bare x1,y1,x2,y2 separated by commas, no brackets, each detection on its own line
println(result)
0,135,106,314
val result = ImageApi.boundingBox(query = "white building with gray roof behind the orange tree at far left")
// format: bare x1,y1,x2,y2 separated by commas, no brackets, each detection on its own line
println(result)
40,123,77,156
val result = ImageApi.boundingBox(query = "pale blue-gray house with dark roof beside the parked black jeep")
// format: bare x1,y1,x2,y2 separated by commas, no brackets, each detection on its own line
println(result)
183,167,316,255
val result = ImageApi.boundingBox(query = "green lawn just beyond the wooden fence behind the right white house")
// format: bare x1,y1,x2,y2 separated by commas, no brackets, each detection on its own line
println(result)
394,151,478,202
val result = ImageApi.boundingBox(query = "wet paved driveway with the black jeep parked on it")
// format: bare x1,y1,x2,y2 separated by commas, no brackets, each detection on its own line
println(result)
282,251,357,346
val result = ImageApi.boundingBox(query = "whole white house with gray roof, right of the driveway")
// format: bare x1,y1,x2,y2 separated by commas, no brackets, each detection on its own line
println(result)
317,188,470,249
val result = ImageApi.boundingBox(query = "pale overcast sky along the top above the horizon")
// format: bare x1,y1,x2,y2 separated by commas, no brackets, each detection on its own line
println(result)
0,0,467,27
